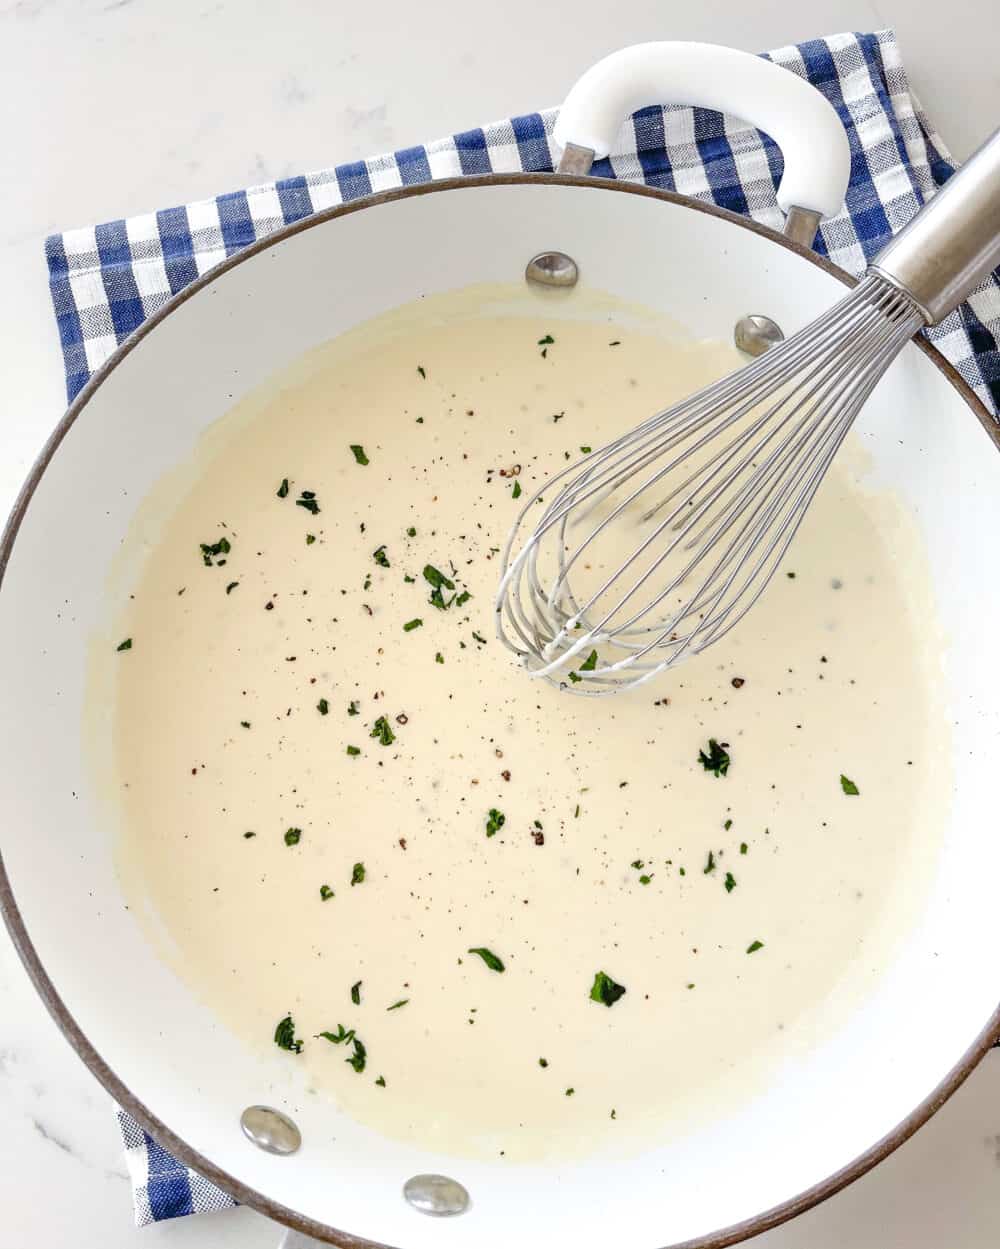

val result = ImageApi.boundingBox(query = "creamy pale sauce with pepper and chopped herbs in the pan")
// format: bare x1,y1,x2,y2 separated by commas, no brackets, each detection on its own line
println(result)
115,283,946,1159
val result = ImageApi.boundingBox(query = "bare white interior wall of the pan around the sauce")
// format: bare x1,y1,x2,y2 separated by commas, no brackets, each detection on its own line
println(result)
0,184,1000,1249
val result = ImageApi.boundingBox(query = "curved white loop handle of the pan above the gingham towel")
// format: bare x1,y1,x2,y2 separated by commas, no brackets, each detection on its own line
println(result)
554,42,850,230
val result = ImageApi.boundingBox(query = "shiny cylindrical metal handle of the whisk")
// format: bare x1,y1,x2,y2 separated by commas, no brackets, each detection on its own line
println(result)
869,130,1000,325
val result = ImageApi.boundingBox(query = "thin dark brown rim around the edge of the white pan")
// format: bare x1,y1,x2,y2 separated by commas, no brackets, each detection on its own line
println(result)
0,174,1000,1249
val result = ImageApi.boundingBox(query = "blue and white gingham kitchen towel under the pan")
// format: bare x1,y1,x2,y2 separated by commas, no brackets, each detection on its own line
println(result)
46,30,1000,1225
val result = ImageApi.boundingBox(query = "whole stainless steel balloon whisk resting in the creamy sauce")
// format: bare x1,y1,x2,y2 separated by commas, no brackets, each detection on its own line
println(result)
496,131,1000,694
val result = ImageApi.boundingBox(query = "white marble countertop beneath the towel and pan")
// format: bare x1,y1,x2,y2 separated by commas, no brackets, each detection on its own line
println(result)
0,0,1000,1249
